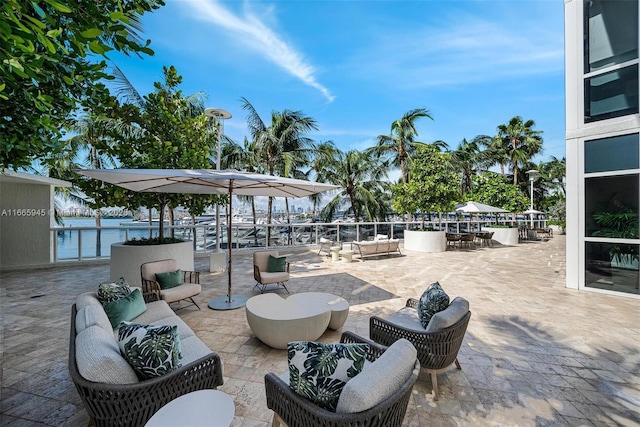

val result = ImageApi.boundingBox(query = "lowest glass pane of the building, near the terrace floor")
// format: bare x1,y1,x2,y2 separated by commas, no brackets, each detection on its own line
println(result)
585,242,640,294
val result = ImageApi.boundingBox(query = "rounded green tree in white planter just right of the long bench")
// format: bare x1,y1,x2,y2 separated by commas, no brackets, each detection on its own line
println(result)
392,145,460,229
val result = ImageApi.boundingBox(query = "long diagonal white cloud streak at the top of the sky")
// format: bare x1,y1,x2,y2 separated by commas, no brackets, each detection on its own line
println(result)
181,0,335,102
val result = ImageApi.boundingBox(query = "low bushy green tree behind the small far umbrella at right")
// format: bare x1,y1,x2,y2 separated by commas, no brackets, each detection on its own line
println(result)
467,172,529,212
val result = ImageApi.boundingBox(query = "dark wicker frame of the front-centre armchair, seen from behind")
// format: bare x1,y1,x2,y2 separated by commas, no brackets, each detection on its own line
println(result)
265,332,420,427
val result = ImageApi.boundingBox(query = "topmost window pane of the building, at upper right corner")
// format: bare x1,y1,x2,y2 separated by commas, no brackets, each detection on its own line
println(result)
584,0,638,73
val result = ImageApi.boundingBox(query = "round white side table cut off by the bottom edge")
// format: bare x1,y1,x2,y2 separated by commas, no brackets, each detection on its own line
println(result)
145,390,236,427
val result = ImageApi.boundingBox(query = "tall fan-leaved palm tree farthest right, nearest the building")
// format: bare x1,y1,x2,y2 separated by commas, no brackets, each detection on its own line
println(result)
498,116,542,185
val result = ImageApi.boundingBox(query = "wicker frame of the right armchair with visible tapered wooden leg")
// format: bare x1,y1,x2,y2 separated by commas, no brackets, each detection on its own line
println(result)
369,298,471,400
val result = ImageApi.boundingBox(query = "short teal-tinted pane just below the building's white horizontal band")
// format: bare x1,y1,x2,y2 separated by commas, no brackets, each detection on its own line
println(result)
584,133,640,173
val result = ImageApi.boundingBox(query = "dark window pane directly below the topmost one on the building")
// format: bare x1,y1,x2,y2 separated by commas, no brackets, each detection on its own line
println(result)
584,64,638,123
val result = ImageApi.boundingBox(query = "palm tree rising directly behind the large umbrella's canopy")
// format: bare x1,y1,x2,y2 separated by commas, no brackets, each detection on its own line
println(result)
242,98,318,229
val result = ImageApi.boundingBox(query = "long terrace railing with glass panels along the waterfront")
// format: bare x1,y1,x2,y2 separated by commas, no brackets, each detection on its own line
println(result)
51,220,544,262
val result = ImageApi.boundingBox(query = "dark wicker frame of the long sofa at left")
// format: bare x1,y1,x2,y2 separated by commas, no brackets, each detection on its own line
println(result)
69,304,223,427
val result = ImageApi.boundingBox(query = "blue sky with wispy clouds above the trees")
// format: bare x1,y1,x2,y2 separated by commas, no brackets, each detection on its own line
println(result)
114,0,565,174
